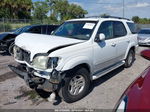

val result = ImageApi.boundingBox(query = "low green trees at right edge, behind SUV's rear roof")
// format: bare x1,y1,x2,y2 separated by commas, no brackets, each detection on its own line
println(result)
132,16,150,24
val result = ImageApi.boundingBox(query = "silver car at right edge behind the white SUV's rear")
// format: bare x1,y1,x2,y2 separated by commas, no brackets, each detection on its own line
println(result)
138,28,150,46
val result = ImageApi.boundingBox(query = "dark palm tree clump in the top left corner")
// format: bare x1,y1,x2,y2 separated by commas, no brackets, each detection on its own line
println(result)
0,0,32,19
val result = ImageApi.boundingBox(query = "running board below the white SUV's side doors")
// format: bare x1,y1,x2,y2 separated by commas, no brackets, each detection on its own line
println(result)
92,61,125,80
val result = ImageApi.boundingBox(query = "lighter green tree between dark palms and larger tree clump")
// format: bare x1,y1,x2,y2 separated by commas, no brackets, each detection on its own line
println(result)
33,1,50,23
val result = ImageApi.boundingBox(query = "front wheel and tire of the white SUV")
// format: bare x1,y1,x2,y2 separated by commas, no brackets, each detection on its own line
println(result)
58,68,90,103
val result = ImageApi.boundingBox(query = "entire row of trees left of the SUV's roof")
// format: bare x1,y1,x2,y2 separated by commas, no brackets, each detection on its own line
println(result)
0,0,88,23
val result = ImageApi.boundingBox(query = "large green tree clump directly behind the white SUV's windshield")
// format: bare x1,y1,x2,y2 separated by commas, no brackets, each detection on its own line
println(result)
47,0,87,21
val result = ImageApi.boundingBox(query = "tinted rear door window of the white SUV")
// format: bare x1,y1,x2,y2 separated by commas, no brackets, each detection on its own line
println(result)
114,21,127,37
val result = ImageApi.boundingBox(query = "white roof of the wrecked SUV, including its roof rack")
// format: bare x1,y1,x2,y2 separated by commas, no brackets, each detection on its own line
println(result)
68,16,133,22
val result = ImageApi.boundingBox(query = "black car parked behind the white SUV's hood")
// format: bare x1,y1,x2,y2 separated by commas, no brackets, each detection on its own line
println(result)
0,25,59,55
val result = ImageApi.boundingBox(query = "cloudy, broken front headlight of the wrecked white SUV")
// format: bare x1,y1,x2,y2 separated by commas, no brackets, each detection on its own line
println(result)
32,54,60,70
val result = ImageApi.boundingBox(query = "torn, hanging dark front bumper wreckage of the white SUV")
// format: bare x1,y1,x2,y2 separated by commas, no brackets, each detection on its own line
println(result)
9,65,62,92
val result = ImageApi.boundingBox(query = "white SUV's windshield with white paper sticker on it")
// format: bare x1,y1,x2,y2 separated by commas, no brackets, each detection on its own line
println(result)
53,21,97,40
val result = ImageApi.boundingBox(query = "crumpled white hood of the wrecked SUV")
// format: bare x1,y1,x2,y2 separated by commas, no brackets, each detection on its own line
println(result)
15,33,85,57
